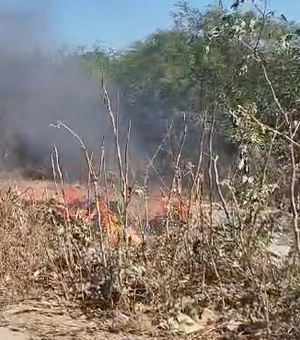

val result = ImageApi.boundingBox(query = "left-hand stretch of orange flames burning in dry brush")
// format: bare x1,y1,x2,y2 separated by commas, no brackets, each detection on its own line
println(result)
16,182,142,247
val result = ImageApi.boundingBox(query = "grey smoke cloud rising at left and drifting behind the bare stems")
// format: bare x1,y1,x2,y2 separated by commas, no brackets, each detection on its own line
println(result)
0,0,234,189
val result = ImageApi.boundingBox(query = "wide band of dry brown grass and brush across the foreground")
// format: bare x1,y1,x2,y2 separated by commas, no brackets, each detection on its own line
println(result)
0,179,300,339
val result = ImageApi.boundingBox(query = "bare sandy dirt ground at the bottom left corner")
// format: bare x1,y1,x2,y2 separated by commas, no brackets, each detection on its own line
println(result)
0,302,153,340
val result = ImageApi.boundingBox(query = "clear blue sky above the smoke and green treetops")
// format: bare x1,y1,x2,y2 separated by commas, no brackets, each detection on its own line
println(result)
0,0,300,47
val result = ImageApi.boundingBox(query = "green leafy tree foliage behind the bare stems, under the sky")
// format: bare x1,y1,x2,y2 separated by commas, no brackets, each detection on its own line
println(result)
78,1,300,181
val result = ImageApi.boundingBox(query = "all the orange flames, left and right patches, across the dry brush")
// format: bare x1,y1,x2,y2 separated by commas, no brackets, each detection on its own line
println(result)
12,182,189,247
